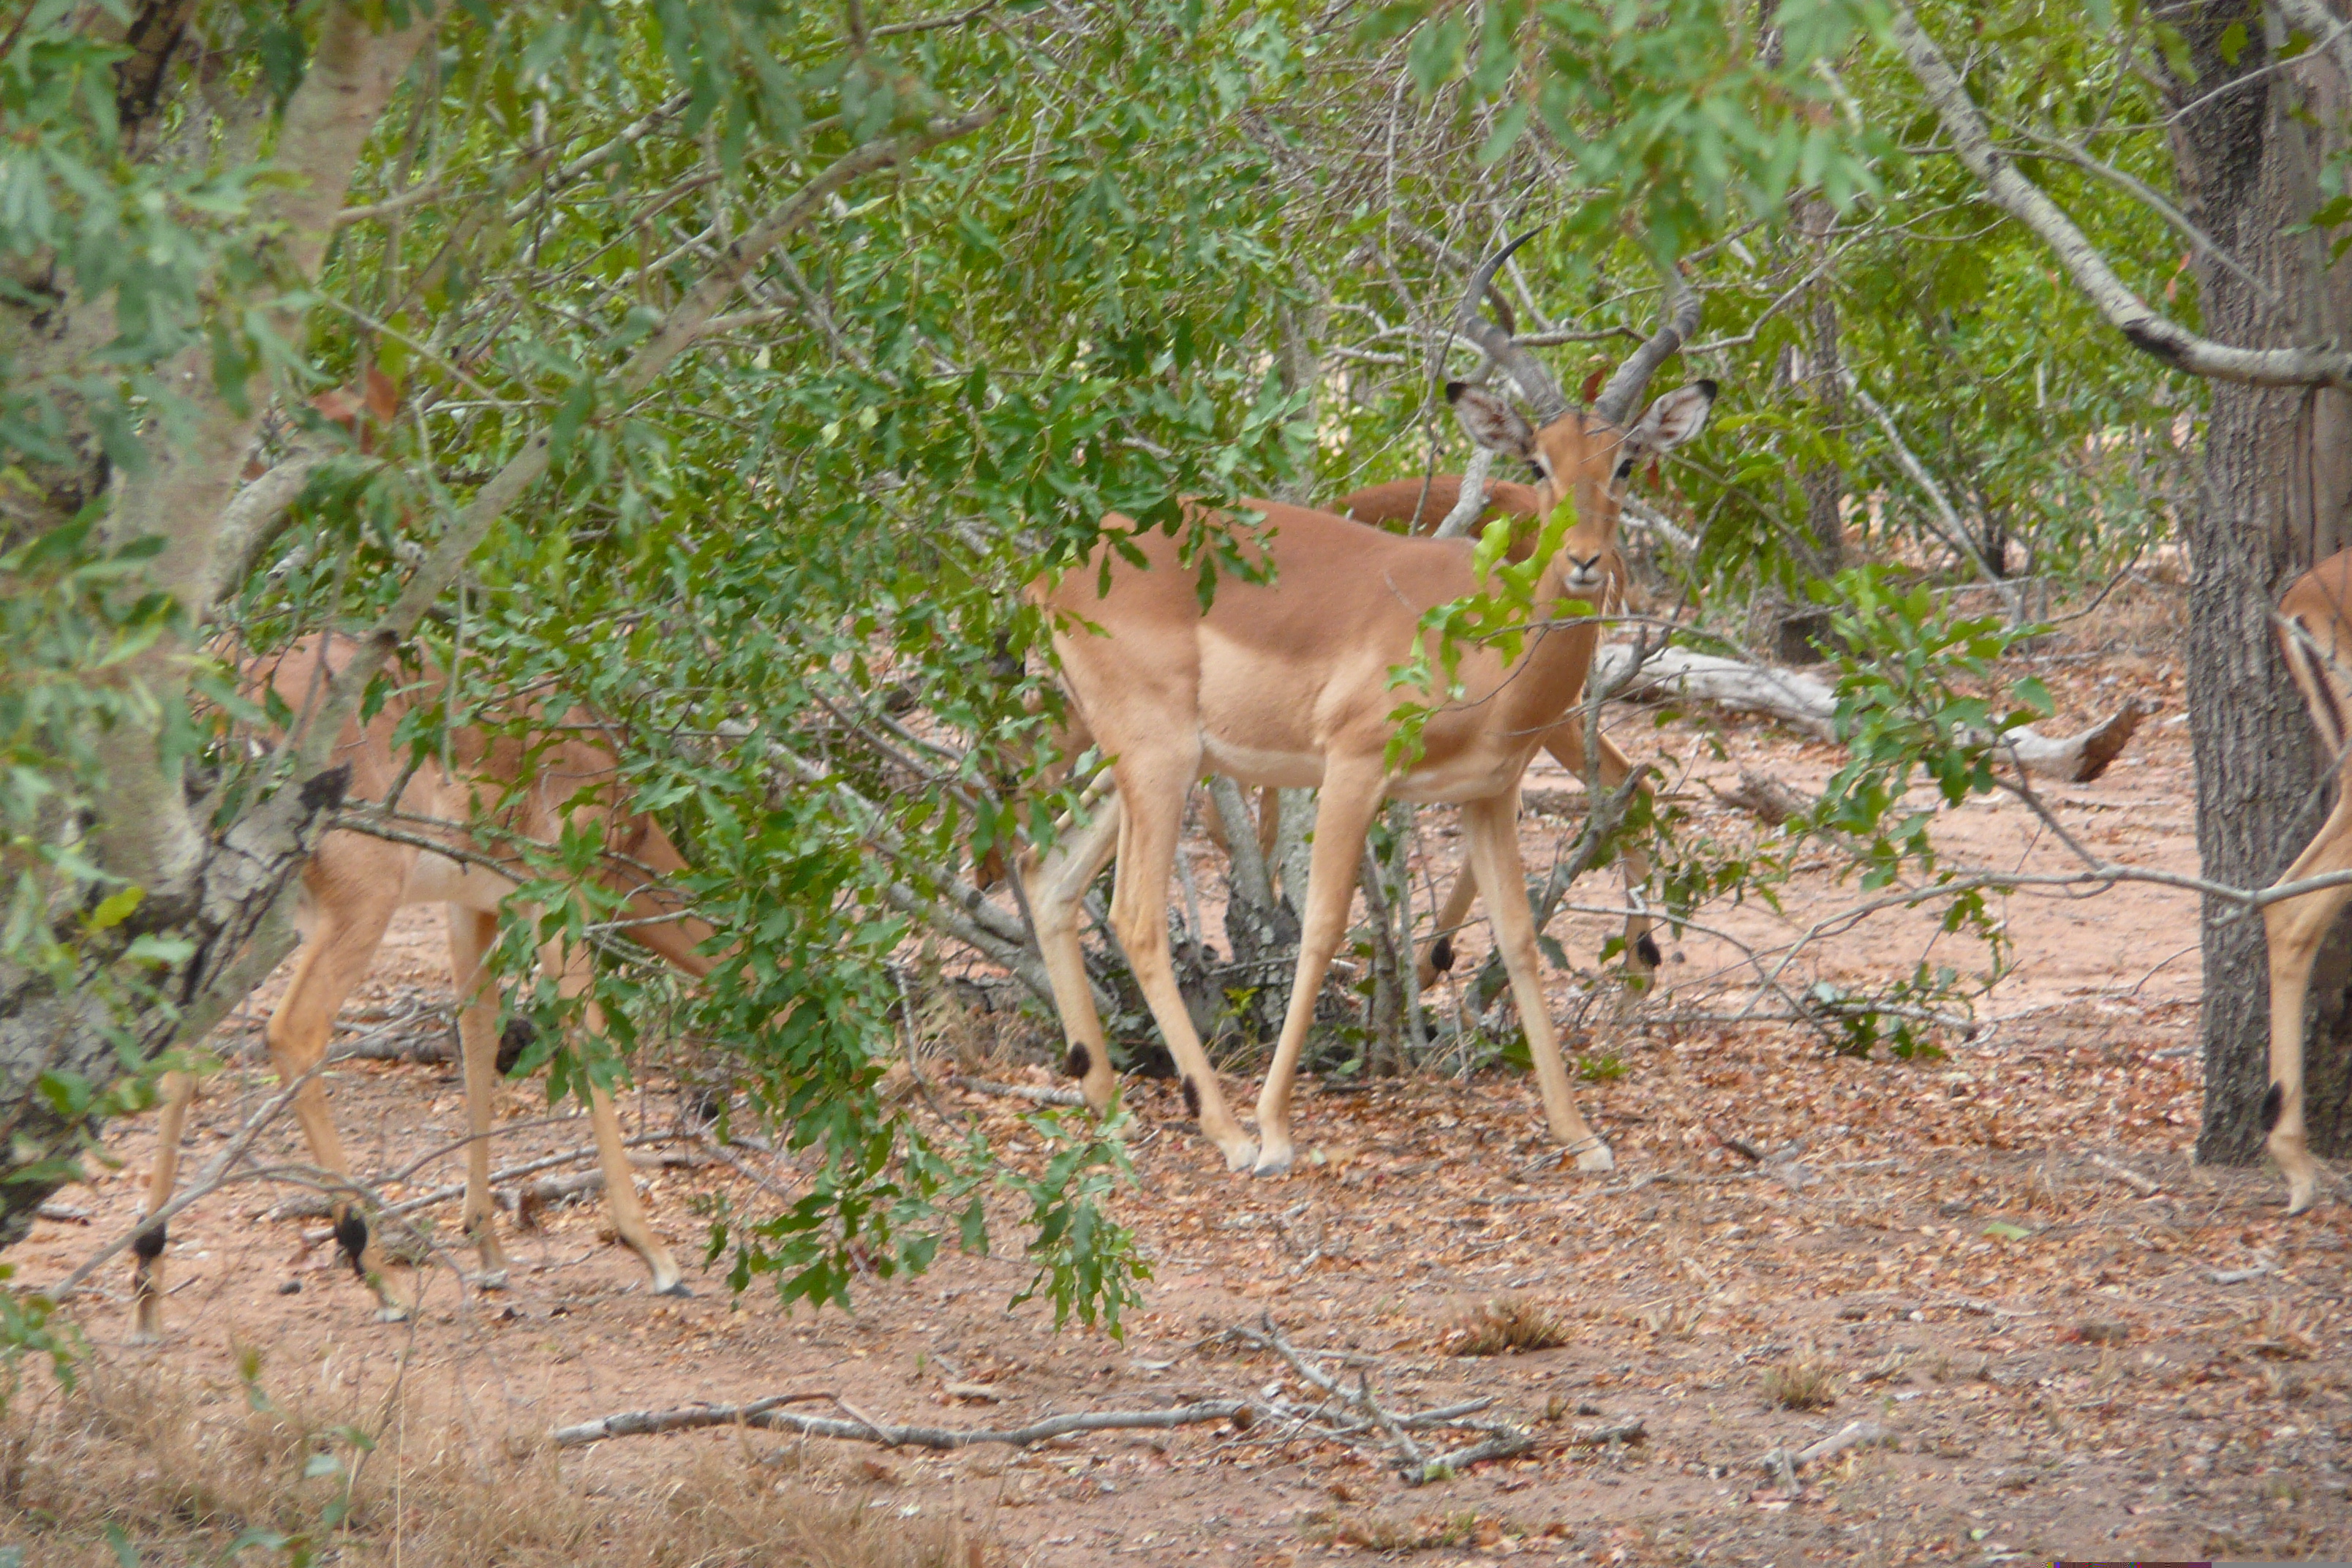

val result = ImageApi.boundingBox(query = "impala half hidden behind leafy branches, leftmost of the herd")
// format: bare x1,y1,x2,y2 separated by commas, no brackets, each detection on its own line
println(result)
132,637,712,1338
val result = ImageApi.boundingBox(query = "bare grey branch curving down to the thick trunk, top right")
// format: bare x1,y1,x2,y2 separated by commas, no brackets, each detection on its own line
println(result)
1893,2,2352,393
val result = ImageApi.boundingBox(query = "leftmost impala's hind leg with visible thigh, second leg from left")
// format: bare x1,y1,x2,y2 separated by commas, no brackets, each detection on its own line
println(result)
268,879,416,1324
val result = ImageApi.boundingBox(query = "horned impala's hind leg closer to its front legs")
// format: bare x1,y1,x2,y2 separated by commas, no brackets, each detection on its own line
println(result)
1110,747,1259,1171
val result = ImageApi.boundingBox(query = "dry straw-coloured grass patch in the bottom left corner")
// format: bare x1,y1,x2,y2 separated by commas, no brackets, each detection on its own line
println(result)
0,1363,1000,1568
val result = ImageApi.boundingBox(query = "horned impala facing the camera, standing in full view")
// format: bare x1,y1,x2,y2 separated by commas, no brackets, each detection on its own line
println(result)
1021,235,1714,1175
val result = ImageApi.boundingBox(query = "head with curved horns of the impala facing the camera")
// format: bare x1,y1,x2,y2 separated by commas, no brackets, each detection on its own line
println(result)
1447,230,1714,604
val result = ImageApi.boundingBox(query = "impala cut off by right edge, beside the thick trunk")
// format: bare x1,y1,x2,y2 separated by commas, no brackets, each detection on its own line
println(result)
2263,550,2352,1213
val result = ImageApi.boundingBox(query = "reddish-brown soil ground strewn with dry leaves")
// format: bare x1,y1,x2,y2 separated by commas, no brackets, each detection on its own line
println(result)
0,620,2352,1566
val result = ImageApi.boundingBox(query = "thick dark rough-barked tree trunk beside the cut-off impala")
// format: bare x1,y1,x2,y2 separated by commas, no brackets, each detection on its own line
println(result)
2174,0,2352,1164
